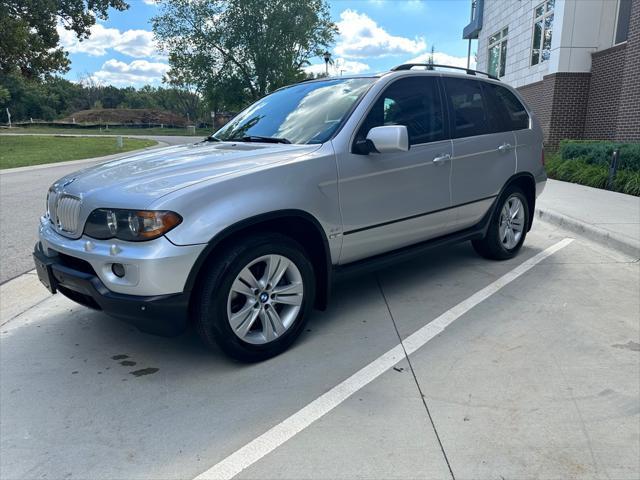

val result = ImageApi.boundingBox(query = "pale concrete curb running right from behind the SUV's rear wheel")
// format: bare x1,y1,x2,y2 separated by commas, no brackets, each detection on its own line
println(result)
536,208,640,258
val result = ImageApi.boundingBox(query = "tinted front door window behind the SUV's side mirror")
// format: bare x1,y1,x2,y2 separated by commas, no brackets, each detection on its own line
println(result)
358,77,445,145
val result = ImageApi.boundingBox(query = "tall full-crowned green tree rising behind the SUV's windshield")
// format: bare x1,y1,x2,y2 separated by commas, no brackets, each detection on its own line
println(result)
152,0,337,110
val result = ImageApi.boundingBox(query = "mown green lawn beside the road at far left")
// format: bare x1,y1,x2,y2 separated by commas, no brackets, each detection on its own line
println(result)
0,135,156,169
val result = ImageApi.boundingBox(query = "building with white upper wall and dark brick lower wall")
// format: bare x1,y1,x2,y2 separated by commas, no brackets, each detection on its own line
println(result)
463,0,640,147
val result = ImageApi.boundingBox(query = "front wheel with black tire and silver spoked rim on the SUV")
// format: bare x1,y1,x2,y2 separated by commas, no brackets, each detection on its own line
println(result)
193,233,315,362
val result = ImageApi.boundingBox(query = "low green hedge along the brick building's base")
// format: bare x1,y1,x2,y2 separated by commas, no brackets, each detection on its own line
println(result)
545,155,640,197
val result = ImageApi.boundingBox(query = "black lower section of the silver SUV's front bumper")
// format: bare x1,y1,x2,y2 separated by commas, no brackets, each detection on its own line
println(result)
33,242,189,336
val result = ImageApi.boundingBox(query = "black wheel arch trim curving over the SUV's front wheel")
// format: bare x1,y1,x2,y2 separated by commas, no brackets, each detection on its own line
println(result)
184,209,332,310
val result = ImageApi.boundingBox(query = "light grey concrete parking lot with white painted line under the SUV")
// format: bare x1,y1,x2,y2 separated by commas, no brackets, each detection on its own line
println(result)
0,222,640,479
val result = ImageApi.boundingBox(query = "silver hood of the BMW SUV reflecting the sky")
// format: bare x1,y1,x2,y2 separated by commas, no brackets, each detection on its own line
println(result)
54,142,319,208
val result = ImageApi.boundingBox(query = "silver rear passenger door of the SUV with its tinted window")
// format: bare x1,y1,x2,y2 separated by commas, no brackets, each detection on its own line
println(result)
443,77,516,229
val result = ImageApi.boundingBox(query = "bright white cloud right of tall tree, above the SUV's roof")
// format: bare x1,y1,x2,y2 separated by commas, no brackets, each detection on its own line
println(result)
335,10,427,58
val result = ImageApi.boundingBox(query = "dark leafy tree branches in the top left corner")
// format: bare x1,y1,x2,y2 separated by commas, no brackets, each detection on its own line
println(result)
0,0,128,78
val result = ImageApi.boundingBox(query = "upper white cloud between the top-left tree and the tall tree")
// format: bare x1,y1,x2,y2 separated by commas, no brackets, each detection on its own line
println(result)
58,23,162,58
